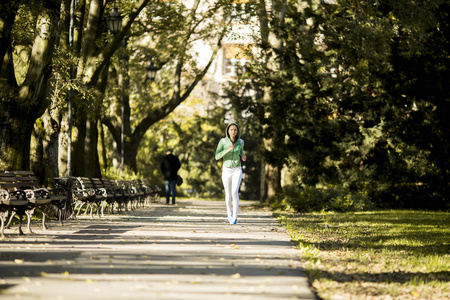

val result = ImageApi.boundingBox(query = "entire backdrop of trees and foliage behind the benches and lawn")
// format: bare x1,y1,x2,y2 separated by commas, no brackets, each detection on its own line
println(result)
0,0,450,208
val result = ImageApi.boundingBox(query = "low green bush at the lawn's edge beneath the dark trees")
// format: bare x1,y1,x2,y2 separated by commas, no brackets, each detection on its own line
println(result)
271,185,372,213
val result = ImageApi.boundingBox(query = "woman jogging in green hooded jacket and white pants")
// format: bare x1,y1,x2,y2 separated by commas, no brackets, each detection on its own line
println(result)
216,122,247,224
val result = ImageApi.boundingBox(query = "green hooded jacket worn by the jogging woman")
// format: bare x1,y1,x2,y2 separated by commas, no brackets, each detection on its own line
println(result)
216,122,244,168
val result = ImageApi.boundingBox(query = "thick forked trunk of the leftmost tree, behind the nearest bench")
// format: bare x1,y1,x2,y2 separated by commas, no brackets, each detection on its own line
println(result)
0,1,60,170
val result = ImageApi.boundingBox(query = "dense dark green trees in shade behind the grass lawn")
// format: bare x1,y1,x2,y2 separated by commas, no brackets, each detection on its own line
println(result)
241,0,450,208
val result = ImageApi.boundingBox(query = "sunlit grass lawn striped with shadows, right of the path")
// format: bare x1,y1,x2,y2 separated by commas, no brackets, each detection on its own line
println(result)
277,210,450,300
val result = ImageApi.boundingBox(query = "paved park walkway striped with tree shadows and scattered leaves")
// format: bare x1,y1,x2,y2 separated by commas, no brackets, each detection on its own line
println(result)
0,200,316,300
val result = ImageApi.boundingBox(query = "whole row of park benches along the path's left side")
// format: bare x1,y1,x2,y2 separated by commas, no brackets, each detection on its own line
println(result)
0,171,161,239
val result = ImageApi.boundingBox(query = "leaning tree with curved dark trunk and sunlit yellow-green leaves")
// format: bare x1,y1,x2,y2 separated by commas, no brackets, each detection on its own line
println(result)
102,0,231,171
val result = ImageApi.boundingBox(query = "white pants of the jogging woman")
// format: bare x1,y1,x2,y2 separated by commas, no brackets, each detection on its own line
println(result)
222,167,242,219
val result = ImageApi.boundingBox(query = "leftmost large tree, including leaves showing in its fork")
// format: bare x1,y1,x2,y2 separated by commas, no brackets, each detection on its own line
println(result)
0,0,61,169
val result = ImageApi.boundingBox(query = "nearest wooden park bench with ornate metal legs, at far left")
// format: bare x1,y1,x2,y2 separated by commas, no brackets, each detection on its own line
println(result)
0,171,68,238
